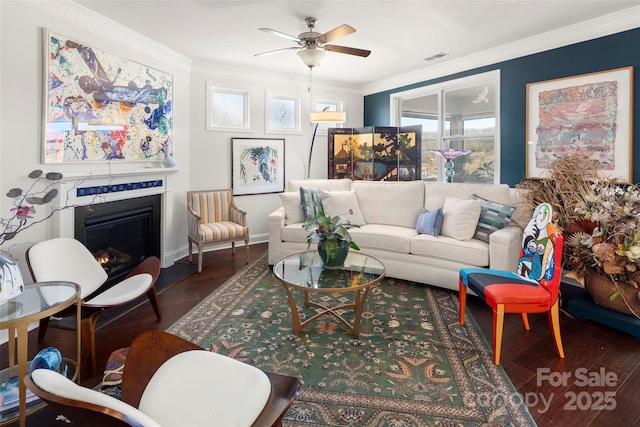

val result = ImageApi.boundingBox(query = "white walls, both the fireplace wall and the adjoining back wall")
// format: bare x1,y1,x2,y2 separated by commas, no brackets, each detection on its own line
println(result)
0,0,364,273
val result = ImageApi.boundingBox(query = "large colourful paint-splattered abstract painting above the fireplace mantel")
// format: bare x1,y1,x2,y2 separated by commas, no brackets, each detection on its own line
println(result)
43,29,173,163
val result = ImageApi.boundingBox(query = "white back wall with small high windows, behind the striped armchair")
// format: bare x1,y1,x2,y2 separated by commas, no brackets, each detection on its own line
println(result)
189,61,364,242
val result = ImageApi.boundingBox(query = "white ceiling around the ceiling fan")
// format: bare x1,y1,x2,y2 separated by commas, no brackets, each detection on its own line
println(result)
76,0,640,85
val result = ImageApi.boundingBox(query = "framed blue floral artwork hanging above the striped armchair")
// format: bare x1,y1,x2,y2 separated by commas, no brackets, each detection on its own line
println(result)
231,138,284,196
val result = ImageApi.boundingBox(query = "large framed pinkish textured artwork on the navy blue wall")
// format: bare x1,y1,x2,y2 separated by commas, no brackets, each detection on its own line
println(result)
526,67,633,182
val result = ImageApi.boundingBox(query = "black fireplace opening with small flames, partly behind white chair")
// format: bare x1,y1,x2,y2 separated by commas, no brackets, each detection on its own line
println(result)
74,194,162,292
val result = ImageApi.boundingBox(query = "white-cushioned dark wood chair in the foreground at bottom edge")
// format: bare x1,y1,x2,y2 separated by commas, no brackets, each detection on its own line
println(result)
24,331,300,427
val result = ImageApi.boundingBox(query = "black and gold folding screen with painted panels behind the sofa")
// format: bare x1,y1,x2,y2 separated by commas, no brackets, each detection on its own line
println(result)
327,125,422,181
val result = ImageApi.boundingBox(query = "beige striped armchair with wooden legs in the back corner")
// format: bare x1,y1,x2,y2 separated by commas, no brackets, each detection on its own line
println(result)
187,190,249,273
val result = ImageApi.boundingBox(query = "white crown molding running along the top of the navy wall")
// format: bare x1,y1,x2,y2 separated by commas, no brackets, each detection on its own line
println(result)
363,6,640,96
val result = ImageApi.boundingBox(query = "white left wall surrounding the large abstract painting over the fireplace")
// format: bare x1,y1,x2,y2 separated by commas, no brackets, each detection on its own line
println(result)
0,0,191,274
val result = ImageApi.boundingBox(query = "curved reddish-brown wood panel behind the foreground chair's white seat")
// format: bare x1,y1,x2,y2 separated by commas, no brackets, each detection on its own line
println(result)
122,331,204,408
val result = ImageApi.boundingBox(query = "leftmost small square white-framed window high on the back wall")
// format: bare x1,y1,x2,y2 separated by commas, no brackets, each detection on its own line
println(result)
206,83,251,132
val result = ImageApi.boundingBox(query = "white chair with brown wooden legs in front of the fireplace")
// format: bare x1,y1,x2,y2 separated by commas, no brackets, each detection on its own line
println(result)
27,237,162,373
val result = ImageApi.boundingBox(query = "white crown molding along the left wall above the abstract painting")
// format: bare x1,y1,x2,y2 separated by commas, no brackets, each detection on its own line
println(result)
18,0,192,71
